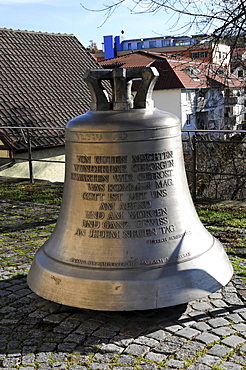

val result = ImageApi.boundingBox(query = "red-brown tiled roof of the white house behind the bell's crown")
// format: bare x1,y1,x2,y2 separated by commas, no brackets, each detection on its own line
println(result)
100,51,242,90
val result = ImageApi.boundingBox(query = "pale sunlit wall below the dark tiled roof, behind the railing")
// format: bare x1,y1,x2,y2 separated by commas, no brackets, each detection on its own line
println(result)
0,146,65,182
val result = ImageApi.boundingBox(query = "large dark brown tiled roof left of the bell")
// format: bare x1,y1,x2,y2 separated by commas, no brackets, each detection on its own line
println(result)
0,29,100,150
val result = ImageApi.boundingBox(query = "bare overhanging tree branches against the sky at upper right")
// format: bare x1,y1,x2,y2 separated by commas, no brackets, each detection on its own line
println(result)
81,0,246,47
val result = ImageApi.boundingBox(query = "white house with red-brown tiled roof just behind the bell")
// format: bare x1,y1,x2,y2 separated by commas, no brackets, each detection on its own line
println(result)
100,51,244,133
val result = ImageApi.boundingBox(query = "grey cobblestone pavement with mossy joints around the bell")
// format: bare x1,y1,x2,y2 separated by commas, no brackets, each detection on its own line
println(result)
0,201,246,370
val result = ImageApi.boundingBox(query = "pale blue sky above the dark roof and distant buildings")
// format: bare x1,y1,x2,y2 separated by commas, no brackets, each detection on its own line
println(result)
0,0,192,49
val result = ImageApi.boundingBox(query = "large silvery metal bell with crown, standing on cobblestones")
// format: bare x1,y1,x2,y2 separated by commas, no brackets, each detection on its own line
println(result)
28,68,233,311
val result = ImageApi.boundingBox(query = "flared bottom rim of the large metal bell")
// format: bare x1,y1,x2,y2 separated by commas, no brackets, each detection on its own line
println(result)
27,239,233,311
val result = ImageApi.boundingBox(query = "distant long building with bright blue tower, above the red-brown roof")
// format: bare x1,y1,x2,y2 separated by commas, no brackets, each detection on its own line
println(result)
95,35,230,67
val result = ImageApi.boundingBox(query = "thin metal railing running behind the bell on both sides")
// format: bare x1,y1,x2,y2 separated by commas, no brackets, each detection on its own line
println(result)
0,126,246,201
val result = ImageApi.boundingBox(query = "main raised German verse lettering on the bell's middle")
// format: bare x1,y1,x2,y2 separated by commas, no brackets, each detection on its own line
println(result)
71,151,176,256
